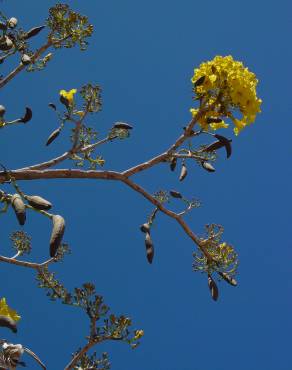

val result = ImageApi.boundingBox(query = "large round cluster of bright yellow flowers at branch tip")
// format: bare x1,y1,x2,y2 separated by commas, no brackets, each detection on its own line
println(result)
191,55,262,135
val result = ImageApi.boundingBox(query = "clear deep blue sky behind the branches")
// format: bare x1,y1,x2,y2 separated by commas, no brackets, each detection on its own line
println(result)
0,0,292,370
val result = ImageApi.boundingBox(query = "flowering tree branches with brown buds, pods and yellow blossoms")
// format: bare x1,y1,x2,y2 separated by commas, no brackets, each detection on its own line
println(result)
0,4,261,370
